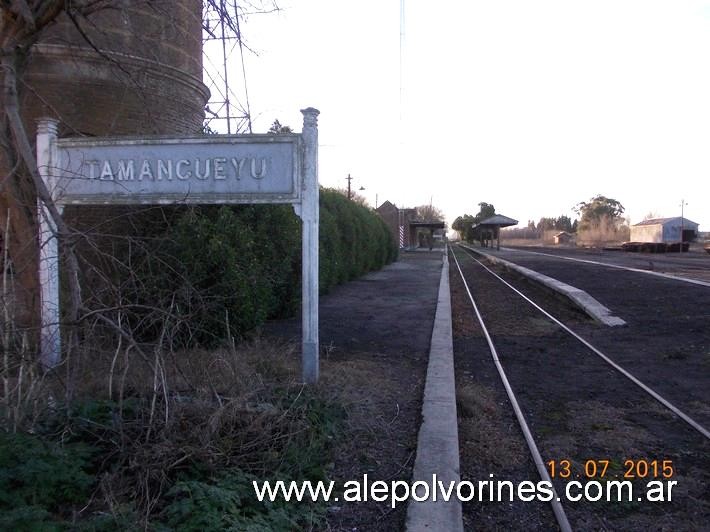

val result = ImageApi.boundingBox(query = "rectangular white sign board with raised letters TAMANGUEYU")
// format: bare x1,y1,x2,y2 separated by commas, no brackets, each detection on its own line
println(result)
55,135,300,204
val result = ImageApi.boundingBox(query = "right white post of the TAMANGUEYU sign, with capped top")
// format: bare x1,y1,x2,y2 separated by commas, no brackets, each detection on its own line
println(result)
301,107,320,384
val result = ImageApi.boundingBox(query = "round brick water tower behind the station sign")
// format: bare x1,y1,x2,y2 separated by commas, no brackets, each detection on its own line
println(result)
0,0,209,324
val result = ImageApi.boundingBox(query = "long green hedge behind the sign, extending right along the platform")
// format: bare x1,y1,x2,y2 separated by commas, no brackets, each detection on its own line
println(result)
112,189,398,345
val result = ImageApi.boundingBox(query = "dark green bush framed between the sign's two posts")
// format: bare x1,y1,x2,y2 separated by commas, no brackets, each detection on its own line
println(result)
122,206,284,346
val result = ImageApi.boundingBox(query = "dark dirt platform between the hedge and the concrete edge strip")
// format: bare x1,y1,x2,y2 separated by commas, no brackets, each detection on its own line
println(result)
264,250,442,531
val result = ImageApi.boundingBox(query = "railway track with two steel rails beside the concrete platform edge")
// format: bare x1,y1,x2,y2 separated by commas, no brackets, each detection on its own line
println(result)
451,248,710,530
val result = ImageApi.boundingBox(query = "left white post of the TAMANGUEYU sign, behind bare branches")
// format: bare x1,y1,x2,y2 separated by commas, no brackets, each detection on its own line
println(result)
37,118,61,369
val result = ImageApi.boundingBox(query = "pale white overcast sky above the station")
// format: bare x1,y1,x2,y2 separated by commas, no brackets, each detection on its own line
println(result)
204,0,710,231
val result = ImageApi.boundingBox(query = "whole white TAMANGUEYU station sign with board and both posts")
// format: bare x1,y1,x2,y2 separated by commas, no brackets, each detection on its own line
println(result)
37,107,319,384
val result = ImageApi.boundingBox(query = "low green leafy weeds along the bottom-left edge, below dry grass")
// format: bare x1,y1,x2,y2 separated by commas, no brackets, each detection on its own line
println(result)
0,386,345,532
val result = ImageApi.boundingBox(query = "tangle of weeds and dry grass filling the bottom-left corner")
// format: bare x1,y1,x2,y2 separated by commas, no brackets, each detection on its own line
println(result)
0,342,345,532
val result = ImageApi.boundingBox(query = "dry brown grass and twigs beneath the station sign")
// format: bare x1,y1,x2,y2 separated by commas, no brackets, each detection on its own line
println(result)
0,339,335,526
